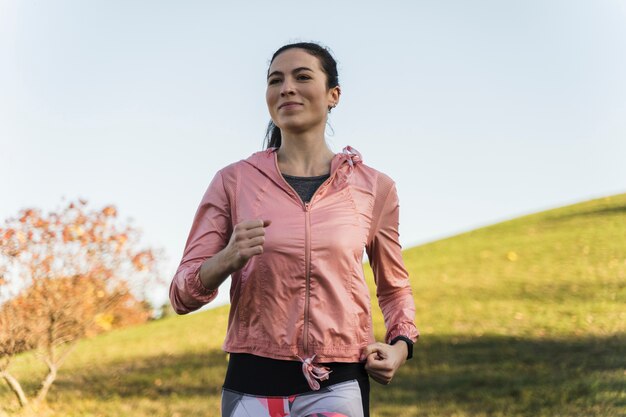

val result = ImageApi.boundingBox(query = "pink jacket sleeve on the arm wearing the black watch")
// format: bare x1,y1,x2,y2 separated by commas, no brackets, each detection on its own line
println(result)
365,175,419,343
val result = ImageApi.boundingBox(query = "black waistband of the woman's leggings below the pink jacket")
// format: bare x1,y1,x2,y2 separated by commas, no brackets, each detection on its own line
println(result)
224,353,368,397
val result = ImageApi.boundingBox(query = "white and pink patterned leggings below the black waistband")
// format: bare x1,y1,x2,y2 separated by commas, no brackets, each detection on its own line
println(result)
222,380,364,417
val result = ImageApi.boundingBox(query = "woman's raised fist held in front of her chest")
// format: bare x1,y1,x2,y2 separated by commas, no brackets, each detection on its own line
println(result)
226,219,271,272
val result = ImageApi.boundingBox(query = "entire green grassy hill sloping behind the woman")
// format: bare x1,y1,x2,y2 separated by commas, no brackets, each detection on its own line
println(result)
0,194,626,417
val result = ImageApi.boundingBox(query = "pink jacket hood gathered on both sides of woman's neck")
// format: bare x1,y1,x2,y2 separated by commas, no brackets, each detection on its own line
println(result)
243,146,363,192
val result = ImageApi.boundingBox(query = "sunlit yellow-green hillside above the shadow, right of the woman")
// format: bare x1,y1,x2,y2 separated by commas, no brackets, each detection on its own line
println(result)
380,194,626,336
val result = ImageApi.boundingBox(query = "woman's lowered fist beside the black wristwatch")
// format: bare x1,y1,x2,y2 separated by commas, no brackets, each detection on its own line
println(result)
361,340,408,385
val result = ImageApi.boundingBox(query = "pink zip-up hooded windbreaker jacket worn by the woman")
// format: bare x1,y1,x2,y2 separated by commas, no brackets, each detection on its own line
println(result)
170,147,418,362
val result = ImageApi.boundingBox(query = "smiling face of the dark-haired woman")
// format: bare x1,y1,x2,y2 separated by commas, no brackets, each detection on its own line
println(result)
265,48,339,133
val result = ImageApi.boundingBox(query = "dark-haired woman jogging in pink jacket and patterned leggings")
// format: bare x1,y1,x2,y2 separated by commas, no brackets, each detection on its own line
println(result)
170,43,418,417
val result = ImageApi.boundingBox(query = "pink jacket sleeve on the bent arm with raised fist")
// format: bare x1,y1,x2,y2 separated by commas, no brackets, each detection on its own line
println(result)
170,171,232,314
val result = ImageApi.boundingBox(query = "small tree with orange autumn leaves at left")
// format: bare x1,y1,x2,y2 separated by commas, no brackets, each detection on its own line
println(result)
0,200,160,408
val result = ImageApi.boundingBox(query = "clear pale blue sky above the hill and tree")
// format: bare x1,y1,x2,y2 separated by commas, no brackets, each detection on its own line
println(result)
0,0,626,306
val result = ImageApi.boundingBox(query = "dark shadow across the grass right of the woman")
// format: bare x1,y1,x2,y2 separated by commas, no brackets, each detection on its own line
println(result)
372,335,626,416
